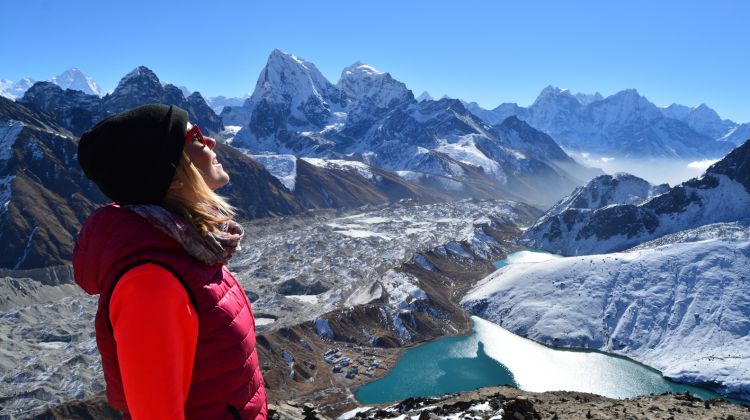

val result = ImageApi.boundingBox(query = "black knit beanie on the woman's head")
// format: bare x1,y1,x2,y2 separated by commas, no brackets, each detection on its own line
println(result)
78,104,188,205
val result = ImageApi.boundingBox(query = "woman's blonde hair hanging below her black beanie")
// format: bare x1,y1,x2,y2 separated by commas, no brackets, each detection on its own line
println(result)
162,152,236,236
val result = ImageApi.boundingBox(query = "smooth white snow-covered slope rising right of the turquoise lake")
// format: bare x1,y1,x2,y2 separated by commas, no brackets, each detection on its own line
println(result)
462,223,750,399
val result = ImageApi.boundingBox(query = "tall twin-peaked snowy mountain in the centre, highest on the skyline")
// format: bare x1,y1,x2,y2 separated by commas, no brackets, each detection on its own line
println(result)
222,50,600,205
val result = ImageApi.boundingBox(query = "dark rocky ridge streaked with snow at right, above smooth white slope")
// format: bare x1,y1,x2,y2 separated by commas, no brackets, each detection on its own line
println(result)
522,140,750,255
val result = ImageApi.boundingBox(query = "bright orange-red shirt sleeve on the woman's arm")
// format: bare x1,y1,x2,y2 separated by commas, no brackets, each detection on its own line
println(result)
109,264,198,420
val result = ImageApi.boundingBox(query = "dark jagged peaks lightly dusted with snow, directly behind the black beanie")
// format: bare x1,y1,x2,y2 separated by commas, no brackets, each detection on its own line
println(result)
18,66,222,135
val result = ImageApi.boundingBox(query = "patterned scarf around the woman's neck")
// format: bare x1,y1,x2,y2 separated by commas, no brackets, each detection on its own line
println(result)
123,204,245,265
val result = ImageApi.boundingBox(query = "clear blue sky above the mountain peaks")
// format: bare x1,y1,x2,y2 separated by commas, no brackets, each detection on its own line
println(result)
5,0,750,122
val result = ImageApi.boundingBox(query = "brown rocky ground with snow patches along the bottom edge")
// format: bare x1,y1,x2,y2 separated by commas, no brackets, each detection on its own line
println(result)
33,387,750,420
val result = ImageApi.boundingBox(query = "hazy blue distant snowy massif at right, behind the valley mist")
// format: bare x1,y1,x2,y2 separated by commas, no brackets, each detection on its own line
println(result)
471,86,729,159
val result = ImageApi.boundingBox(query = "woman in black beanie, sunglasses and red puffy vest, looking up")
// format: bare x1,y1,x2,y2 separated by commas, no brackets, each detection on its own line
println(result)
73,105,267,420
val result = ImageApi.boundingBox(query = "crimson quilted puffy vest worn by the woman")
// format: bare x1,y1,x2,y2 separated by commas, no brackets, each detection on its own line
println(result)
73,205,267,419
